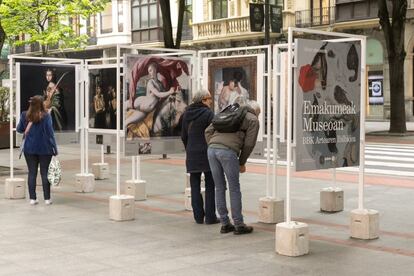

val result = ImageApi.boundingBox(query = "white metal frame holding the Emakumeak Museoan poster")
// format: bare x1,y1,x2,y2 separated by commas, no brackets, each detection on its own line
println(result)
286,27,366,223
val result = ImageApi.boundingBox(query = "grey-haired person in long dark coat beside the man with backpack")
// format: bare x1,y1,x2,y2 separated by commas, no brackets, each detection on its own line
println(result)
181,90,220,224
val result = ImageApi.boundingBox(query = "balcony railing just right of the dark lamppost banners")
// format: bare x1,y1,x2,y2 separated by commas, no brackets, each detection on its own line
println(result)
295,6,335,28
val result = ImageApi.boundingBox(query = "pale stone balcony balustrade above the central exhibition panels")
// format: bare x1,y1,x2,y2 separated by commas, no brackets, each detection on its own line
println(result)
193,16,250,40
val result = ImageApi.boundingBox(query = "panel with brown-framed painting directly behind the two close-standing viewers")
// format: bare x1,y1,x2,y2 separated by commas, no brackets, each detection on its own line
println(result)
203,54,266,141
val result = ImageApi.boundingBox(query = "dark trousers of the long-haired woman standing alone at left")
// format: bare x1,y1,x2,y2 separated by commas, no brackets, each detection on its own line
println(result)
24,153,52,200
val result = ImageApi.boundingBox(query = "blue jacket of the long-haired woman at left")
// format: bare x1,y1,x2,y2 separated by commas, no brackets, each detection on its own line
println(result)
16,112,58,155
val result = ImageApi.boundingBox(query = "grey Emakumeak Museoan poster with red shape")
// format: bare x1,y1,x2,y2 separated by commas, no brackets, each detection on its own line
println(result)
295,39,361,171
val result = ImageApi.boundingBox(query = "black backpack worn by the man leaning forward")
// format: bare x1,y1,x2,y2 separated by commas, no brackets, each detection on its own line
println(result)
212,103,247,133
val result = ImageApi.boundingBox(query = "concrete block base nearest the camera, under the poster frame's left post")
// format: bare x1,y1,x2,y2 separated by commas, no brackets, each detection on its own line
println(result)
276,221,309,257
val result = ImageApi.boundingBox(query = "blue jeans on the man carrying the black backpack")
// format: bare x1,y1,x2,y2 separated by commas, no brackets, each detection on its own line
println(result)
207,147,244,226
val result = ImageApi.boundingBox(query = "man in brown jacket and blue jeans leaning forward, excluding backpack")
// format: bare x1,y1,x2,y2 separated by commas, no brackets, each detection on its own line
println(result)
205,101,260,235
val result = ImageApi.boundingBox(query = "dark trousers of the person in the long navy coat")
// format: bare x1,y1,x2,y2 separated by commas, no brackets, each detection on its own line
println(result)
190,172,217,223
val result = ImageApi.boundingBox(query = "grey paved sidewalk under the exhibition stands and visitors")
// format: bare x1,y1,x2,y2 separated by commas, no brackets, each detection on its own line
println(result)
0,143,414,276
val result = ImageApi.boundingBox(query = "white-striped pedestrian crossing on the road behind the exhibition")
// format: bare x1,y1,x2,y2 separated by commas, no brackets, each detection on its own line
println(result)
254,143,414,177
